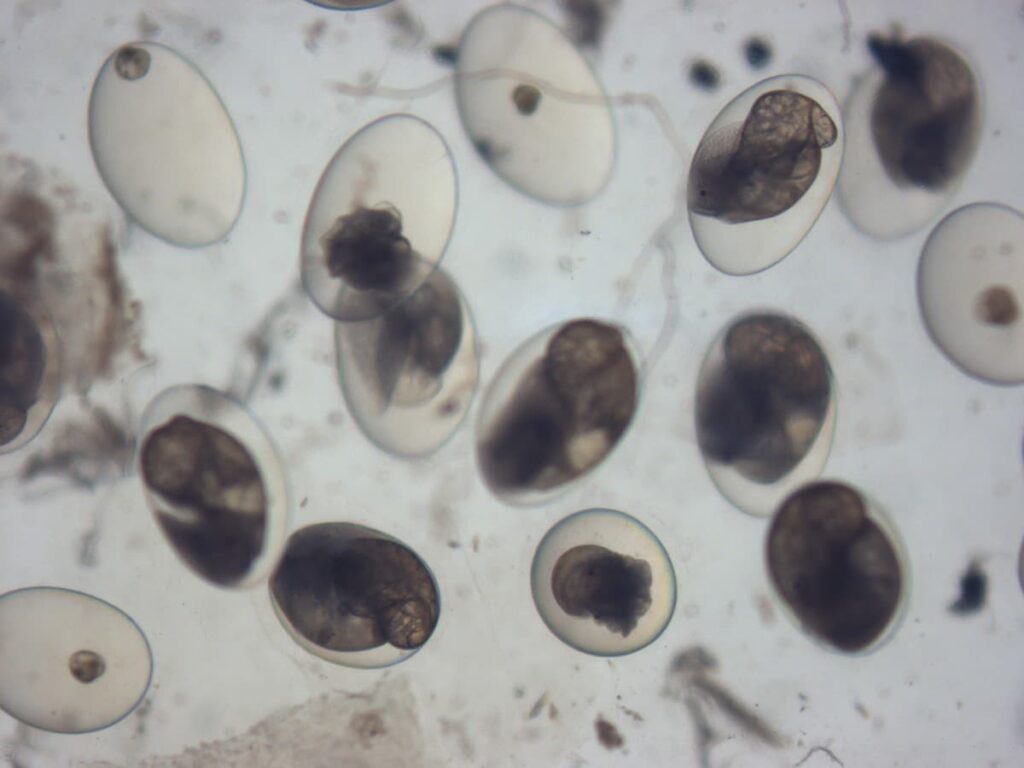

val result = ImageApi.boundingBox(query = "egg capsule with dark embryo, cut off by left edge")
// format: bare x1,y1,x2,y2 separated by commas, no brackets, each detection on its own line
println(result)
0,289,60,454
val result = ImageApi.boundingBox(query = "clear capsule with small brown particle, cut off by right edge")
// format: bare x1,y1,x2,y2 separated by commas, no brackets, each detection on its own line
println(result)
918,203,1024,384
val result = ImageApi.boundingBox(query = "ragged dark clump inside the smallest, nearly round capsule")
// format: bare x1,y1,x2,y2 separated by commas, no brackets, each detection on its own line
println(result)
551,545,651,637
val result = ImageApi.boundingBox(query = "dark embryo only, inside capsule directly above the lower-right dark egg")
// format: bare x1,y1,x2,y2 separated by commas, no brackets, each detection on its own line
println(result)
697,314,831,483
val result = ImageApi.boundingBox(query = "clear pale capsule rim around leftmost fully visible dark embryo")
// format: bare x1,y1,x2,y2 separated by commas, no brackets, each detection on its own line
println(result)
133,384,292,591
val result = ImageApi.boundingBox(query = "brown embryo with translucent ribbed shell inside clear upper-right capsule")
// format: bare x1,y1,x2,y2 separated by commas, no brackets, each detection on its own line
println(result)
687,90,839,224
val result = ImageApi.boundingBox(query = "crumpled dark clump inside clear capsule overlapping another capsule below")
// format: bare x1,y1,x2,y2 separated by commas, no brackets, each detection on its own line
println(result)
323,206,416,291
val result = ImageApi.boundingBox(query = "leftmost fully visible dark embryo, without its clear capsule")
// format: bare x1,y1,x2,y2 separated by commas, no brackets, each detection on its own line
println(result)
141,416,267,585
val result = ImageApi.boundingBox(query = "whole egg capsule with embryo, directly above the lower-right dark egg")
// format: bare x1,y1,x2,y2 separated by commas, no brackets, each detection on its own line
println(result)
696,312,837,515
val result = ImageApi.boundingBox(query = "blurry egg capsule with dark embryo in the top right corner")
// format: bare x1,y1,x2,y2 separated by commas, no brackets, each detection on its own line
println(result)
839,35,982,240
